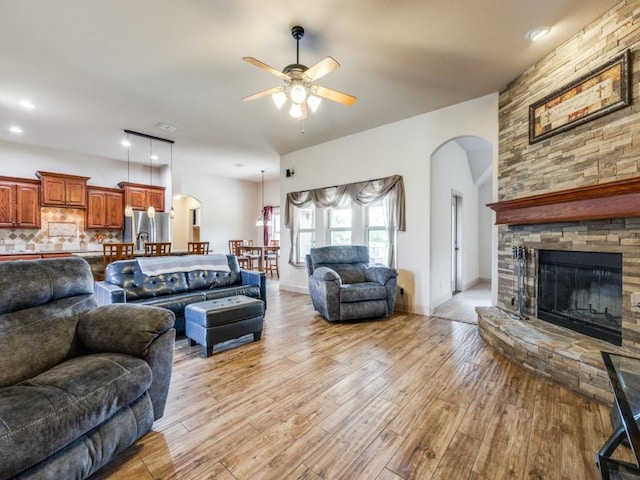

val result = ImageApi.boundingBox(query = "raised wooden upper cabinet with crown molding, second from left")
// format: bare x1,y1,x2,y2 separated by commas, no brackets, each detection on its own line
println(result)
36,171,90,208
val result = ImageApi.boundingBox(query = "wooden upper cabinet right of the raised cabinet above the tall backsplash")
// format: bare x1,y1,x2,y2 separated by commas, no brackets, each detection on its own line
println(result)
85,187,124,230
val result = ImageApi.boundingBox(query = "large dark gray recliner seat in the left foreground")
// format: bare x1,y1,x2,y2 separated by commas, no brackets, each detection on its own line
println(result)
0,257,175,480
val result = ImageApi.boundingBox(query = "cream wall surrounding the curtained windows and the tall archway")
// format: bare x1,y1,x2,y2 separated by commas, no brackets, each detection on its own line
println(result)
280,93,498,314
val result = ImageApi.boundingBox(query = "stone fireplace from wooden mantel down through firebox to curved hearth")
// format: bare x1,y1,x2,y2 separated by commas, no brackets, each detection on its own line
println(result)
477,179,640,404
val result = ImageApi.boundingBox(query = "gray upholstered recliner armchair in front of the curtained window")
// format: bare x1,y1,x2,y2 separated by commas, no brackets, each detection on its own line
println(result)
306,245,398,322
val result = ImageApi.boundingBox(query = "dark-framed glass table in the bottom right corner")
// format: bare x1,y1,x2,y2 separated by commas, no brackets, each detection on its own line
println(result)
596,352,640,480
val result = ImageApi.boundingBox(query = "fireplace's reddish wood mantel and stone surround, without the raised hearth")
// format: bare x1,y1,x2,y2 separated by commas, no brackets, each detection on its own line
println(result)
489,178,640,354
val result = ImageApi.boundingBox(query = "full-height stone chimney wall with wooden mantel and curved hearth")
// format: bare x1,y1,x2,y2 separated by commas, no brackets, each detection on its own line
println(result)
478,0,640,404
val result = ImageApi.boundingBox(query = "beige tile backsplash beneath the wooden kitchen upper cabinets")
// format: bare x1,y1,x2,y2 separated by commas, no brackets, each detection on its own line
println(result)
0,207,122,253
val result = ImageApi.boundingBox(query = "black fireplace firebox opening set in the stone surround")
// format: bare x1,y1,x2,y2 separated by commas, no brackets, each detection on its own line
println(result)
537,250,622,345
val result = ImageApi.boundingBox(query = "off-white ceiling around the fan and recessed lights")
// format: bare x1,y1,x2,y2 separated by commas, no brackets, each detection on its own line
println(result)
0,0,618,181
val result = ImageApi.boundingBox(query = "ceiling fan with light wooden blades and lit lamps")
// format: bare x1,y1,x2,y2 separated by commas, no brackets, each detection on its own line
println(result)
242,25,357,119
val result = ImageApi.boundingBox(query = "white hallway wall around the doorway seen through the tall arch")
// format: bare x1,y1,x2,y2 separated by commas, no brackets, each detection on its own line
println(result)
425,141,479,309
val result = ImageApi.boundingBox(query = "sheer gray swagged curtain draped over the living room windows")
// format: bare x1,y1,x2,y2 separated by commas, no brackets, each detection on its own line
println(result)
284,175,407,265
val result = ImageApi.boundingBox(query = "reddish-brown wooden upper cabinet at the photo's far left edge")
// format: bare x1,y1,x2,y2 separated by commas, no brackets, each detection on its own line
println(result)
0,177,40,228
